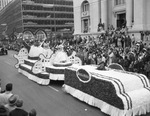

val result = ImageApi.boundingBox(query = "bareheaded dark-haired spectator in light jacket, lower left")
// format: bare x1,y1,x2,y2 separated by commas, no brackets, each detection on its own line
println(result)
0,83,13,105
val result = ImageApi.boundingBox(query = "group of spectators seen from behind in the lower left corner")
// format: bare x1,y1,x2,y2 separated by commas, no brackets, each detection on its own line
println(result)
0,83,36,116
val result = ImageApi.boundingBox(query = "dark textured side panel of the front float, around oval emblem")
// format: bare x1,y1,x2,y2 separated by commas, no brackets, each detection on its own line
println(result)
64,69,124,109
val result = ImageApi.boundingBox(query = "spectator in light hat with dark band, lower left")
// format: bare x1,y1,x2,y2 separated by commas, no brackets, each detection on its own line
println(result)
5,95,19,112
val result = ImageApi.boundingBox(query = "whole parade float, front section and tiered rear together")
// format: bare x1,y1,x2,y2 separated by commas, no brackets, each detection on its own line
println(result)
14,30,150,116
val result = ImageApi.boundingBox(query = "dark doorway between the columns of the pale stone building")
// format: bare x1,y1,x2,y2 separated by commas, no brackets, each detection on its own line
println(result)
117,13,126,28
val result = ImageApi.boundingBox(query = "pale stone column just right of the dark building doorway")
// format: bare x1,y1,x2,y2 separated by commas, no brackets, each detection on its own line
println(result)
126,0,133,28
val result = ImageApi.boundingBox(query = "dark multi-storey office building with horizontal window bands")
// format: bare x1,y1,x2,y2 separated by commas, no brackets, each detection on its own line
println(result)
0,0,74,39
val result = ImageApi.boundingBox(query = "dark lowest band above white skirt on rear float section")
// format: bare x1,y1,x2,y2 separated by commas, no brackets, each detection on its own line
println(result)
19,65,49,79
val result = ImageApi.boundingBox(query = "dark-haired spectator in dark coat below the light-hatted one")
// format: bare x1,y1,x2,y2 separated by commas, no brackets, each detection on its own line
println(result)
9,99,28,116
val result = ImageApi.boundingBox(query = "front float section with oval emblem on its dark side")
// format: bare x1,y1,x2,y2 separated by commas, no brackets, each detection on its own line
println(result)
63,65,150,116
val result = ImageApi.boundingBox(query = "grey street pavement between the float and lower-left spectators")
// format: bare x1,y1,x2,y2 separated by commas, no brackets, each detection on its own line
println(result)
0,51,150,116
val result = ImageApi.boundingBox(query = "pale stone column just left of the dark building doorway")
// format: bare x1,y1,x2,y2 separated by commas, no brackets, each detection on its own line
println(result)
101,0,108,29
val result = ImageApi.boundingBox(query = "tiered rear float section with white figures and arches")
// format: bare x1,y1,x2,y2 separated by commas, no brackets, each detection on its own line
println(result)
14,30,82,85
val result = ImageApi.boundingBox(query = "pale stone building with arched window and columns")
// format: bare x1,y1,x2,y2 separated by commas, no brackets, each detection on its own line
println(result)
73,0,150,41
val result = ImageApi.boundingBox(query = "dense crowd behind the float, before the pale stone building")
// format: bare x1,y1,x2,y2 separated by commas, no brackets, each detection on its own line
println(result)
51,26,150,78
